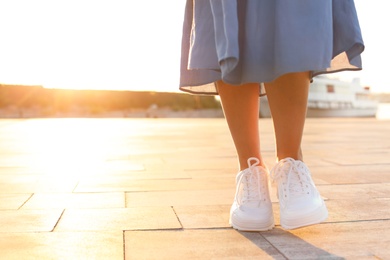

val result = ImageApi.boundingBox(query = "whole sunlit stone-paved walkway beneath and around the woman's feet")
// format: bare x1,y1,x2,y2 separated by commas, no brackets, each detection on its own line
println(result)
0,119,390,259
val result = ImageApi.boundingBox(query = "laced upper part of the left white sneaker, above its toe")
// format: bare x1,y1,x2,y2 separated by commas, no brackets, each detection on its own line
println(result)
235,157,267,205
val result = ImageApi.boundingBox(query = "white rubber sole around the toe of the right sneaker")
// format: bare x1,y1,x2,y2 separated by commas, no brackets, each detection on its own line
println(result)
280,203,328,230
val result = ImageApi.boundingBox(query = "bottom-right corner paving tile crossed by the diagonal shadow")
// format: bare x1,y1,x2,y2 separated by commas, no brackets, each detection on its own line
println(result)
261,220,390,259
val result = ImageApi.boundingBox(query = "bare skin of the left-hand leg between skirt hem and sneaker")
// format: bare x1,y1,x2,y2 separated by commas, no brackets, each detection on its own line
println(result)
217,81,264,171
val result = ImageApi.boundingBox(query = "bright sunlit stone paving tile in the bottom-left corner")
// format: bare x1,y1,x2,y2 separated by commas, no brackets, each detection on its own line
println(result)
0,230,124,260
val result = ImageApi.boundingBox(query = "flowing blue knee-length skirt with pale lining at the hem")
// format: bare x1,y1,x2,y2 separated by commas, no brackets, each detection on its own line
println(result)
180,0,364,94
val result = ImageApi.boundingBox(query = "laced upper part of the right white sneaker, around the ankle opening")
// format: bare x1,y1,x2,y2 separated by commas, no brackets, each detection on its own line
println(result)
271,158,312,200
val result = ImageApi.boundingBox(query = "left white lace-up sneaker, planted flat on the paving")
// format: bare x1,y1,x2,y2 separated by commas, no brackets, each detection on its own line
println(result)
229,158,274,231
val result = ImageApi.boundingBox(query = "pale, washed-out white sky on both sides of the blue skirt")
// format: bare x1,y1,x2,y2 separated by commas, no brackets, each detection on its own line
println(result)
0,0,390,92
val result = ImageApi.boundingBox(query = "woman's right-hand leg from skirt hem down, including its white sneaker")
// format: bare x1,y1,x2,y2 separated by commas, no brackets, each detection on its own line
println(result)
265,72,328,229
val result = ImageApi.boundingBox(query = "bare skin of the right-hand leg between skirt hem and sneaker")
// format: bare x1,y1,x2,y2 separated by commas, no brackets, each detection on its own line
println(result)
265,72,310,160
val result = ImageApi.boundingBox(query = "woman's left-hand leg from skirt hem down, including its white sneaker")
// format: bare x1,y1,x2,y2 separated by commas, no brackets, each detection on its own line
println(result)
217,81,274,231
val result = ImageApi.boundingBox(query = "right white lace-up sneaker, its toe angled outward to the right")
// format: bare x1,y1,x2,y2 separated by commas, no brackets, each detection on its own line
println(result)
271,158,328,229
